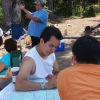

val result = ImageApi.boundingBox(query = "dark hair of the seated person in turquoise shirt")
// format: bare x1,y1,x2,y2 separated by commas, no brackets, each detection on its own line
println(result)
4,38,17,52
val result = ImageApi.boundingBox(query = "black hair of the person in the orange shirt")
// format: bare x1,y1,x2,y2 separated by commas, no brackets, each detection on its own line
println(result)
72,36,100,64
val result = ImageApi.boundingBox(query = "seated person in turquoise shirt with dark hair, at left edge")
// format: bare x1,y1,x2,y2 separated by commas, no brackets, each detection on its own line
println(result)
0,38,17,75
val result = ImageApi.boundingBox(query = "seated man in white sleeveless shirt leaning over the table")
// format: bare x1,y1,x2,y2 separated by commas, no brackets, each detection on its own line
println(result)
15,27,63,91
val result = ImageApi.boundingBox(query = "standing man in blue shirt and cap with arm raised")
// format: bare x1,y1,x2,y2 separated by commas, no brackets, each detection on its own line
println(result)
20,0,48,47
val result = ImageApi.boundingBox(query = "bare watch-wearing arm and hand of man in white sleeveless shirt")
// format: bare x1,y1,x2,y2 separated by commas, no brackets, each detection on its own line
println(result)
15,57,57,91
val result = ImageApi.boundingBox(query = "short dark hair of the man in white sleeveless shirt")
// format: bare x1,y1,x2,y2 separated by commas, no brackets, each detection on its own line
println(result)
40,26,63,43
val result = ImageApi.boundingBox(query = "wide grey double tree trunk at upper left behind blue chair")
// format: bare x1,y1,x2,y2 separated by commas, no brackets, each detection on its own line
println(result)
2,0,21,28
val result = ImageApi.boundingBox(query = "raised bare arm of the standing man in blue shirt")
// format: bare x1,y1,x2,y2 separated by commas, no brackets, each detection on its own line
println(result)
20,4,40,22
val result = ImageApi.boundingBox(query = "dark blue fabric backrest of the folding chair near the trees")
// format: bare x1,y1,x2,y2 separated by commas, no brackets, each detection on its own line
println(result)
11,24,23,40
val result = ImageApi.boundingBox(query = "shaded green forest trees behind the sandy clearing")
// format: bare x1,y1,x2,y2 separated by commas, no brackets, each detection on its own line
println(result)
0,0,100,28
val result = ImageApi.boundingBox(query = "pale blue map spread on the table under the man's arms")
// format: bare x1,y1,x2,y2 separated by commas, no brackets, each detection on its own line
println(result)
0,80,60,100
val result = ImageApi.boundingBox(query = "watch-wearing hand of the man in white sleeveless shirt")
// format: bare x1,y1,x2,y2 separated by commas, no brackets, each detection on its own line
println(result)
44,78,57,89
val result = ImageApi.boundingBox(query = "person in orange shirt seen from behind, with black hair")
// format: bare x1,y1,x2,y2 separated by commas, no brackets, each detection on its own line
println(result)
57,36,100,100
